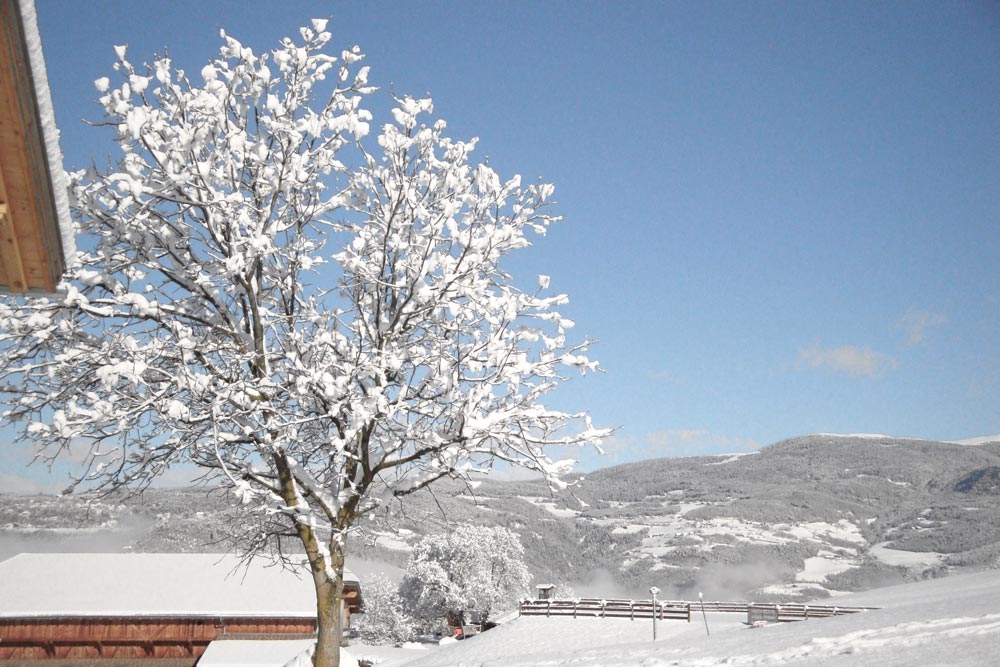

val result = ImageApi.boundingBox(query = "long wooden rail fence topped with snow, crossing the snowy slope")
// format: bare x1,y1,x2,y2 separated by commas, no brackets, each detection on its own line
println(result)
520,598,877,623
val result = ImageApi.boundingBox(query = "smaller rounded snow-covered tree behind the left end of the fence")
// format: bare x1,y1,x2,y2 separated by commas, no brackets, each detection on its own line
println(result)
400,525,531,627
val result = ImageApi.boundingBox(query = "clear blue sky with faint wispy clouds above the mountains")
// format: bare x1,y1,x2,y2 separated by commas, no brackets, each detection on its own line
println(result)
0,0,1000,490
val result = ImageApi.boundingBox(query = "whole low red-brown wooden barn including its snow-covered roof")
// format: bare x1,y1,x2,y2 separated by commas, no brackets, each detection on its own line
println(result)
0,554,362,667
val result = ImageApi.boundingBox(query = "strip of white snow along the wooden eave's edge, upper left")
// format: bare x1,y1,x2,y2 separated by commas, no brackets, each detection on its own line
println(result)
17,0,76,267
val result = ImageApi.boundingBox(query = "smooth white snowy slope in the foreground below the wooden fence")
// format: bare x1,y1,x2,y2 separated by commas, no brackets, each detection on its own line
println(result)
349,571,1000,667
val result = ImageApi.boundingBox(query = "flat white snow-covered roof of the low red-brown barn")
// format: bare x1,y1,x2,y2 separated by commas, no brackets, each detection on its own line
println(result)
0,553,359,618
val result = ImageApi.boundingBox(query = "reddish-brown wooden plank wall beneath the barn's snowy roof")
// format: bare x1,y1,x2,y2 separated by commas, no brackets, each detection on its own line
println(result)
0,616,316,665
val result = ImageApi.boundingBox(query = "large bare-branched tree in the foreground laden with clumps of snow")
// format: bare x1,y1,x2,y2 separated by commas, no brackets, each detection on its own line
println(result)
0,20,606,665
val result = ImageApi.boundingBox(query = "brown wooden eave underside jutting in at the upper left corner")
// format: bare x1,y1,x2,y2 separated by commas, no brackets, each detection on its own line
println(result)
0,0,64,293
